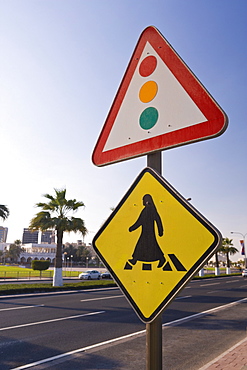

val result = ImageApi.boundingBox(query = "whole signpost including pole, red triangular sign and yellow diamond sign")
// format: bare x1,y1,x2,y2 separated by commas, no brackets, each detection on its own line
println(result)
92,27,228,370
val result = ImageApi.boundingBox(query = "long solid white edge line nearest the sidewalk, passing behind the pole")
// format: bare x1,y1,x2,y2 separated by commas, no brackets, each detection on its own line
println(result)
11,298,247,370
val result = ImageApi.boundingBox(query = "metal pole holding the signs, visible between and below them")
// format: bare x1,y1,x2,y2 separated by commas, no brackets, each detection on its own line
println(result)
146,152,162,370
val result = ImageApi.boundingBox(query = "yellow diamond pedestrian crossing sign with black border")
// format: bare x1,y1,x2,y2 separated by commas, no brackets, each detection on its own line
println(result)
93,168,221,322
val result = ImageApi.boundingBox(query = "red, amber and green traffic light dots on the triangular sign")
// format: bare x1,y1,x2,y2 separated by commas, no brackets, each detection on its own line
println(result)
139,55,159,130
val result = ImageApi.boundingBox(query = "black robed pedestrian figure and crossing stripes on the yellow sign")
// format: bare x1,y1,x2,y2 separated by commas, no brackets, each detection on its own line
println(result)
124,194,186,271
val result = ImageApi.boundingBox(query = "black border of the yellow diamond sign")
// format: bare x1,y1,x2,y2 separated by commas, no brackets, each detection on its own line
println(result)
92,167,222,323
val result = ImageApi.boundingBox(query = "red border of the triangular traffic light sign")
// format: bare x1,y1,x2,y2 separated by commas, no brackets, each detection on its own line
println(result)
92,26,228,166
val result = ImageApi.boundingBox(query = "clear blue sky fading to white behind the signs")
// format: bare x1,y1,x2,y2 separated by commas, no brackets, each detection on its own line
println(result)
0,0,247,257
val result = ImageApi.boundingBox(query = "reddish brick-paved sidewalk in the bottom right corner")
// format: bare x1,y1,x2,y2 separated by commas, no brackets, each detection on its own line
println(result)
199,337,247,370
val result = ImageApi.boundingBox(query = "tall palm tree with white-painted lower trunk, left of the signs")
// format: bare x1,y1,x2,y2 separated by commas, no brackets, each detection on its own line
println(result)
29,189,87,286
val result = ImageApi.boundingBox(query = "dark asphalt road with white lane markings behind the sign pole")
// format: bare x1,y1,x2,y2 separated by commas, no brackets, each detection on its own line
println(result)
0,276,247,370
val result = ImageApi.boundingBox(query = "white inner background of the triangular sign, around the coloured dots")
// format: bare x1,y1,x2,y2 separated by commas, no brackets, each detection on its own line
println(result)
103,42,207,152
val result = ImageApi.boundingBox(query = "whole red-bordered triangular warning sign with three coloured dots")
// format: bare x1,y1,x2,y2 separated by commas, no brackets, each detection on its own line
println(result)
93,27,227,166
